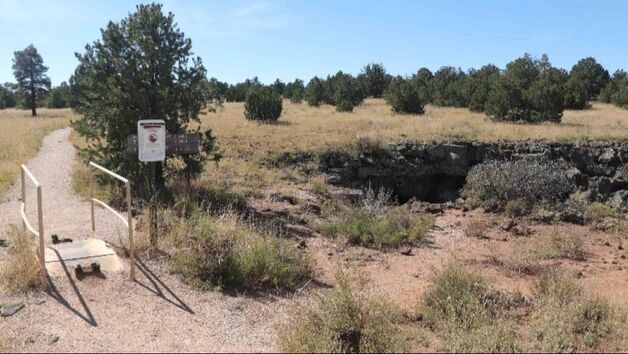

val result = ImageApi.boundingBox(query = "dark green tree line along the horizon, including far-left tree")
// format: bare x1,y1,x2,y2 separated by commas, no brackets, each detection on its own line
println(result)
0,24,628,122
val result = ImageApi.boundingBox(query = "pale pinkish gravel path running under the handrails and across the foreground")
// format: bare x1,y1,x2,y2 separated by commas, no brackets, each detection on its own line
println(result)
0,129,290,352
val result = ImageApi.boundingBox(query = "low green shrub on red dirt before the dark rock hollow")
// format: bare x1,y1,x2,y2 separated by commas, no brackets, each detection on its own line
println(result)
318,210,434,249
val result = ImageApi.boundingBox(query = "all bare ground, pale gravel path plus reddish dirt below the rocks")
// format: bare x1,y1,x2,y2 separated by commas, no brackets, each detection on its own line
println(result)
0,130,628,352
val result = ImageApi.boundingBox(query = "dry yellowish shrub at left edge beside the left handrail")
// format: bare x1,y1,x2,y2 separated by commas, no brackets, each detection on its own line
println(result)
0,225,45,292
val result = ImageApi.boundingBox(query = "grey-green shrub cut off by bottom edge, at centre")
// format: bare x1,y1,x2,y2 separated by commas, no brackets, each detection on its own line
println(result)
279,276,405,353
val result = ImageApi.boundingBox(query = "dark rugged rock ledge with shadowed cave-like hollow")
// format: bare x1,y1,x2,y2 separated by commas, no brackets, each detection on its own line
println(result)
320,140,628,211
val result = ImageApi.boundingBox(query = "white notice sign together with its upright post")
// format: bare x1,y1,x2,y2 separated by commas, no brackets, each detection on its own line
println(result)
137,120,166,256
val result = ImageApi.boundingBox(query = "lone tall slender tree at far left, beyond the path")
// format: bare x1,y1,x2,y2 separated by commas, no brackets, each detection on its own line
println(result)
13,44,50,117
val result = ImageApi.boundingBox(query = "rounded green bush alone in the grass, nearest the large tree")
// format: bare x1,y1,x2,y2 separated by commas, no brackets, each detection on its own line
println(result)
244,87,283,122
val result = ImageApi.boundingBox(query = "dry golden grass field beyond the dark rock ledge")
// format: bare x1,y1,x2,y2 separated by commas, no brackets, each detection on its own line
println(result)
201,99,628,194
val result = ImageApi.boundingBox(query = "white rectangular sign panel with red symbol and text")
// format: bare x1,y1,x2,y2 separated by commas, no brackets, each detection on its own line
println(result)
137,119,166,162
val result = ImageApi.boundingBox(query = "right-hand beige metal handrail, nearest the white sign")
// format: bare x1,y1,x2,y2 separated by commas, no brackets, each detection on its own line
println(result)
89,162,135,280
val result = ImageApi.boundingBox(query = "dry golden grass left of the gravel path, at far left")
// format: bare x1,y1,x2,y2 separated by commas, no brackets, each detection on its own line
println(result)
0,108,74,196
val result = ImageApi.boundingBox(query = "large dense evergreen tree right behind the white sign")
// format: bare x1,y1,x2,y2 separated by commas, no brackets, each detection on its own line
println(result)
72,4,216,196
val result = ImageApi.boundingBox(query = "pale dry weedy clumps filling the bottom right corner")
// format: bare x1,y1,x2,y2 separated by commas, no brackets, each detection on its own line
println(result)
420,264,628,352
